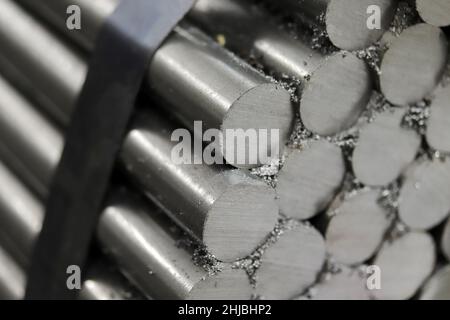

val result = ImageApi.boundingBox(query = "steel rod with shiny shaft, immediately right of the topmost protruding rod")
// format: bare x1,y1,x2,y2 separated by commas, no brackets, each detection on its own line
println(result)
188,0,373,136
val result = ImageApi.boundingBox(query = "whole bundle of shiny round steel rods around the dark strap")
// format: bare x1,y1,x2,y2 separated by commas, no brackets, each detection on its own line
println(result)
0,0,450,300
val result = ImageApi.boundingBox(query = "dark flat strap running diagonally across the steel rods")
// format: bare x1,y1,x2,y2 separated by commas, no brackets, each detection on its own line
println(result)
26,0,194,299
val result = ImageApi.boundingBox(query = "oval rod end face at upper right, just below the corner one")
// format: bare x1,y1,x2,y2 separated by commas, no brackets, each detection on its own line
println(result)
380,23,448,105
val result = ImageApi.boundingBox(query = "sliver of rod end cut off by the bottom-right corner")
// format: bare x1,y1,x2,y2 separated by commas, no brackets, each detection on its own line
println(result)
419,265,450,300
